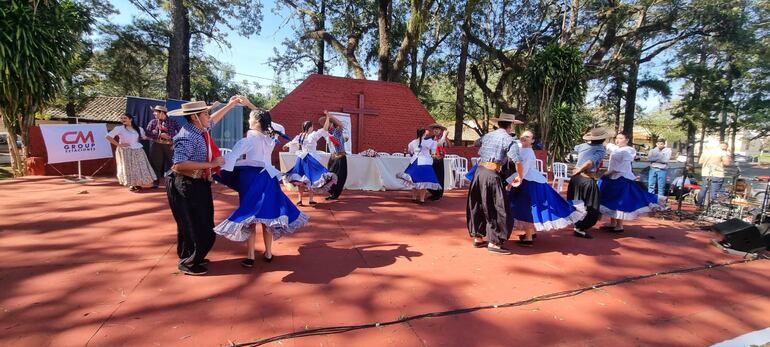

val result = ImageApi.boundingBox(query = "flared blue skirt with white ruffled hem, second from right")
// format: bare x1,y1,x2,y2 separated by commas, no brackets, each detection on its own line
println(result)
508,180,586,231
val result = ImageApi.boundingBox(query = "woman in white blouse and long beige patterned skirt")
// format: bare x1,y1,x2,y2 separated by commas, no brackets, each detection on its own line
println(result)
106,113,157,192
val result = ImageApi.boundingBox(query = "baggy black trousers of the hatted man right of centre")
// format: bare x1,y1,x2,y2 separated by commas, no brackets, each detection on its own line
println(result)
465,166,513,245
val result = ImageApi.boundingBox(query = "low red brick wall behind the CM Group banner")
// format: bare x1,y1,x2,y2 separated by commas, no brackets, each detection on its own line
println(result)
29,126,116,176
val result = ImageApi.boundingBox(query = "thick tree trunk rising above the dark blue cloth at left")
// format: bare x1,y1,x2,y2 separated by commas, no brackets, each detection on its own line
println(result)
166,0,190,99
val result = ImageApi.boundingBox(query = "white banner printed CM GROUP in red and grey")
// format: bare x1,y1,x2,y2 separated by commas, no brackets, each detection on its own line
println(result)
40,123,112,164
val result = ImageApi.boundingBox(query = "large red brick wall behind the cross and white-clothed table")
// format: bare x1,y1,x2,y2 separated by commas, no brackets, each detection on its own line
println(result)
270,74,435,160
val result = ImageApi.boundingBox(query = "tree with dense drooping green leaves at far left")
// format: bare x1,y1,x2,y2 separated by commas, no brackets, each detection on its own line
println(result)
0,0,91,175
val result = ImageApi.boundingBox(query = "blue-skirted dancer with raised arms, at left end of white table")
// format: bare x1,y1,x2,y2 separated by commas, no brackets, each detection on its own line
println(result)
284,121,337,206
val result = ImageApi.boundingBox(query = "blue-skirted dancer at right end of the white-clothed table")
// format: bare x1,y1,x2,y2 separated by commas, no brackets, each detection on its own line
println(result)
396,128,441,203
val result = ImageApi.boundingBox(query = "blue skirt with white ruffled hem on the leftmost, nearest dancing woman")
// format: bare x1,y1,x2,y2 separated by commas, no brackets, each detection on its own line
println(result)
214,166,310,241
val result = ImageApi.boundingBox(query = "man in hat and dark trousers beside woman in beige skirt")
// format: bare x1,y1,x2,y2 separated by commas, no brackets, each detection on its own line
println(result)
146,106,182,188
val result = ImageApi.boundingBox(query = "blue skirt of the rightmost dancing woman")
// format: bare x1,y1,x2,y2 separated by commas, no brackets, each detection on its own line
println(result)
599,177,667,220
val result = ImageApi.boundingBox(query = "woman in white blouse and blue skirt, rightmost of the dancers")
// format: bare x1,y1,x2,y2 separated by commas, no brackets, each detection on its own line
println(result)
599,133,666,233
